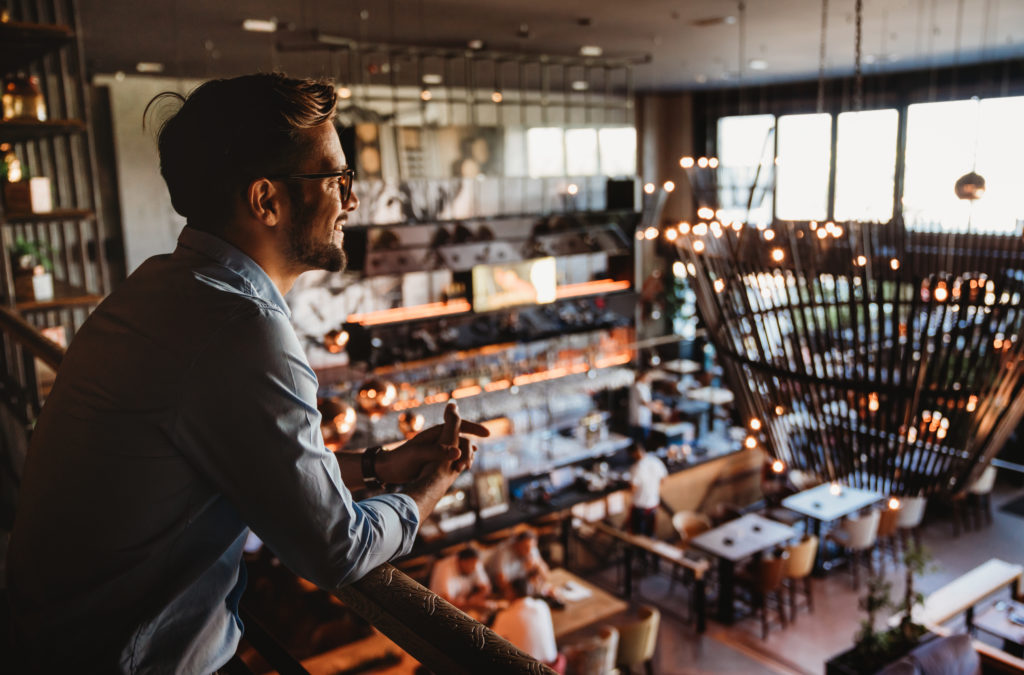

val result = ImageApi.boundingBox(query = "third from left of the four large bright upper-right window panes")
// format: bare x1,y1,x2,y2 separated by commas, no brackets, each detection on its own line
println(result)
835,110,899,222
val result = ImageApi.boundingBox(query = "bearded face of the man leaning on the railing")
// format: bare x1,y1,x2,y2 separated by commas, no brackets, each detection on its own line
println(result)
287,122,359,271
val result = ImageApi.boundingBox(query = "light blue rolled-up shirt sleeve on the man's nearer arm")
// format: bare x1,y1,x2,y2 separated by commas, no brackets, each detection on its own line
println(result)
175,304,419,588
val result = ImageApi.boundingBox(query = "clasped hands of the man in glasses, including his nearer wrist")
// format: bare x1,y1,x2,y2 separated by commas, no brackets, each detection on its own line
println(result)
399,403,488,522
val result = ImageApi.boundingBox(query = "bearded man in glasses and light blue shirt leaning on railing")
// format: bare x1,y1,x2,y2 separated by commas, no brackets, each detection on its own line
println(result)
8,75,486,673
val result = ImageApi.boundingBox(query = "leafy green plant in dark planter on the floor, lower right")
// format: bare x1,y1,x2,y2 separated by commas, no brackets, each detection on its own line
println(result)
825,542,931,675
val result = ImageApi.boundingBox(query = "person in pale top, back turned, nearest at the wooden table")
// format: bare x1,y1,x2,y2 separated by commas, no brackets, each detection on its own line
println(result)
490,577,565,673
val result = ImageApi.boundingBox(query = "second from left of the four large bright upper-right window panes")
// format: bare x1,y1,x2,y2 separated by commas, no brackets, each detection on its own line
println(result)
775,113,831,220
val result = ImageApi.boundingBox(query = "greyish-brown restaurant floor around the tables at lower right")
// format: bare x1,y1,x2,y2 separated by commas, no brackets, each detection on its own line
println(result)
598,486,1024,675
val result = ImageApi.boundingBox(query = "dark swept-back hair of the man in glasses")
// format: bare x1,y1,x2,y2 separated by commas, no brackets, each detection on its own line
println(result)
144,73,337,225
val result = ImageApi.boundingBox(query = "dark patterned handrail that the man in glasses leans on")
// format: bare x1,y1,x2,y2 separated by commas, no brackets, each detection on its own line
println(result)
0,306,554,675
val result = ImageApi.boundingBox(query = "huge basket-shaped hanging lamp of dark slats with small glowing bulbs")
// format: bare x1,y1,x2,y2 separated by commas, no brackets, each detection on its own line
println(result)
675,218,1024,496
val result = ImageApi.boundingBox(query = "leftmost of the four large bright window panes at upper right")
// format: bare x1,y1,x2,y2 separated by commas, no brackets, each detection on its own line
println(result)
718,115,775,224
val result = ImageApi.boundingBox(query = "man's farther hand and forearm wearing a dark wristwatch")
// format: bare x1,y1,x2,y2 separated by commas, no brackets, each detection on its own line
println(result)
377,403,490,484
